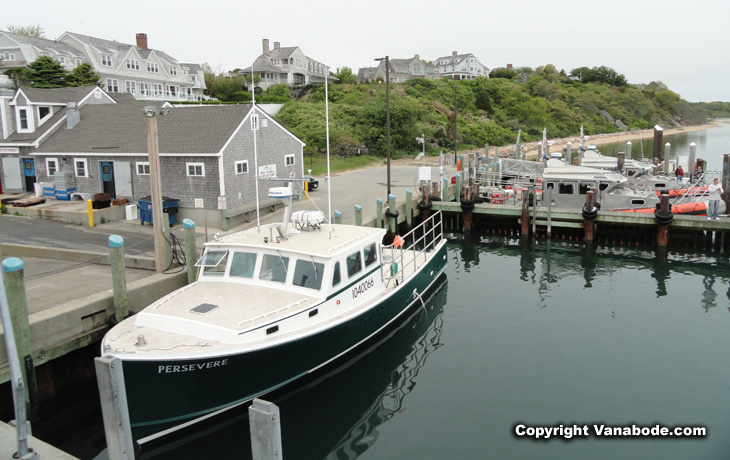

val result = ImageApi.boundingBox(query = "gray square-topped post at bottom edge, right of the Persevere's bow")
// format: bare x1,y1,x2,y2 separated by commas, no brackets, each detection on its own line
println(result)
248,398,284,460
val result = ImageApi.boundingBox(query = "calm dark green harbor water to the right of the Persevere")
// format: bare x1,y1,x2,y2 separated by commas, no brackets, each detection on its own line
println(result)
116,235,730,459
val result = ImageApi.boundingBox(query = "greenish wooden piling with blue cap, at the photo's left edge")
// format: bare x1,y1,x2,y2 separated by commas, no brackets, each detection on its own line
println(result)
2,257,35,407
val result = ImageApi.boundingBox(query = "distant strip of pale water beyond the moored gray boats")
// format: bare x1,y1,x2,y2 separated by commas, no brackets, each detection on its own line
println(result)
587,122,730,171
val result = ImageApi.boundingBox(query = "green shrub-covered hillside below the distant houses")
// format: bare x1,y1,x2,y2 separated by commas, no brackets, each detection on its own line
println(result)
268,66,706,164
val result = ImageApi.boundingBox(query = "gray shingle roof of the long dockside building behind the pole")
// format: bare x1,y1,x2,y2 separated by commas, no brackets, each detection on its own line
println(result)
36,102,251,154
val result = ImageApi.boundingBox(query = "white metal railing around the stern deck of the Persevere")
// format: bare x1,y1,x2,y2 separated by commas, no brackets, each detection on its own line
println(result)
380,211,444,287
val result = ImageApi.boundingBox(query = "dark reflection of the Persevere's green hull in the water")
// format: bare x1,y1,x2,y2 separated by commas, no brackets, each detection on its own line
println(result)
135,275,448,460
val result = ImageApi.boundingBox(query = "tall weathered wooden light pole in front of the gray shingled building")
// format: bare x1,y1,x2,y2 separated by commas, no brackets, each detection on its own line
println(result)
145,106,165,273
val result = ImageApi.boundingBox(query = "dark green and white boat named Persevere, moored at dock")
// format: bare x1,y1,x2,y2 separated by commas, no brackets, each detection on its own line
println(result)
102,187,446,439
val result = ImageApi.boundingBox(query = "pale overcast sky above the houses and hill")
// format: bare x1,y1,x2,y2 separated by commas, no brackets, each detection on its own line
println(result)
5,0,730,102
